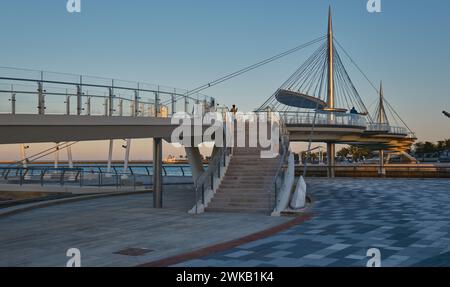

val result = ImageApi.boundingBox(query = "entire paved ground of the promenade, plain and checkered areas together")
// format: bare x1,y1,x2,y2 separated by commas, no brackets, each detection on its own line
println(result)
0,179,450,267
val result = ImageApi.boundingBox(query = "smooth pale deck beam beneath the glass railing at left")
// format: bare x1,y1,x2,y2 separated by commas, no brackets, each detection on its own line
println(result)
0,115,176,144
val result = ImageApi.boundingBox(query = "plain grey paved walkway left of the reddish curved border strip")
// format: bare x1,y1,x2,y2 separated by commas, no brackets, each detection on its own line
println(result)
0,187,289,267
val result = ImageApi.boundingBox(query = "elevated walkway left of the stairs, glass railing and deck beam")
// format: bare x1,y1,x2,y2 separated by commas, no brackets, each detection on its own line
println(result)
0,68,216,144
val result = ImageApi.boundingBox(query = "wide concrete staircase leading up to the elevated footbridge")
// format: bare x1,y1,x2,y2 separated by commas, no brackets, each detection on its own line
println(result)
205,148,279,213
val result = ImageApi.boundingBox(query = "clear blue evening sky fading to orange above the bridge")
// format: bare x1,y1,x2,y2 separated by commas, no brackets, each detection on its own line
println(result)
0,0,450,159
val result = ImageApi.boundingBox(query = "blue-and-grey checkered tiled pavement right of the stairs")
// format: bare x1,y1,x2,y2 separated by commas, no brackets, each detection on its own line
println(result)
176,179,450,267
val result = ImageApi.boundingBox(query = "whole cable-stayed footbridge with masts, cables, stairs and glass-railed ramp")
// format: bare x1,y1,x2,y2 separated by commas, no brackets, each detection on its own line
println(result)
0,9,416,216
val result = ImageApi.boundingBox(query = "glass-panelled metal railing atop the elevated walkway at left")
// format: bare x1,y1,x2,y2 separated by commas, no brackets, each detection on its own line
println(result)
0,67,215,117
